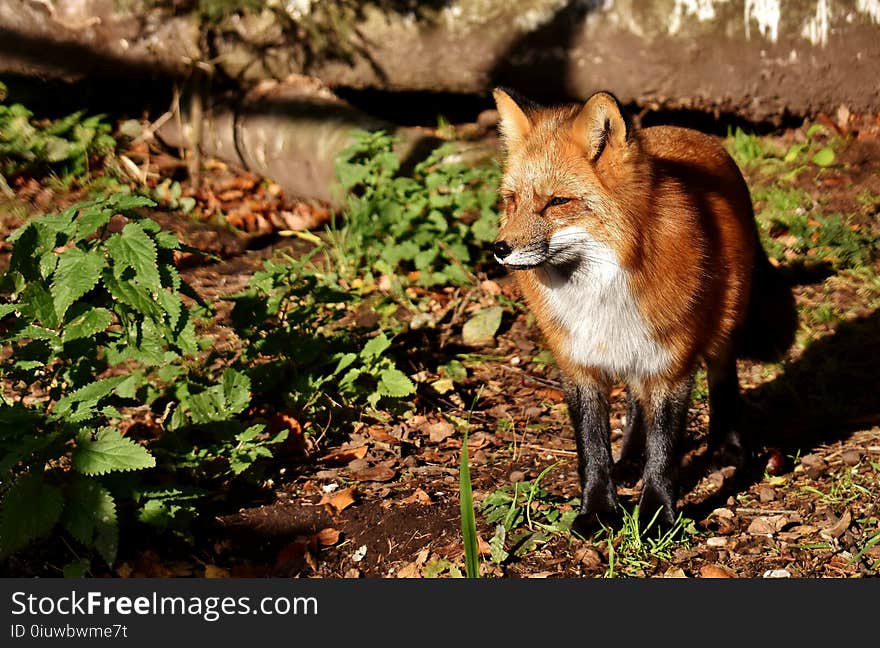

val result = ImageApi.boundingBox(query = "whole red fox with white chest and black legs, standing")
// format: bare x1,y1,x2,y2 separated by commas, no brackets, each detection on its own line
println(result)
492,88,797,529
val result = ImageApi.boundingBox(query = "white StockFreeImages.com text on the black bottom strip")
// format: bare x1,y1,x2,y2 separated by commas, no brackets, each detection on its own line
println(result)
10,590,318,622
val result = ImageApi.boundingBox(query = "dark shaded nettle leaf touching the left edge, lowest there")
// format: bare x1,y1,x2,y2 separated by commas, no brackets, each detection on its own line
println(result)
0,470,62,555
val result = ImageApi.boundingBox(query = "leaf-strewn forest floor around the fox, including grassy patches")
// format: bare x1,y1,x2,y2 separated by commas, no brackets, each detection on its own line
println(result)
2,104,880,578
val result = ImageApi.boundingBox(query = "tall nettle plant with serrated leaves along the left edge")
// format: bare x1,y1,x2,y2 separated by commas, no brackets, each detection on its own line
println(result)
0,194,197,564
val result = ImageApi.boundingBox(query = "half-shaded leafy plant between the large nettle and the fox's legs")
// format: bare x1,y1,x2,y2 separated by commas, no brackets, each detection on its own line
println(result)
232,248,415,426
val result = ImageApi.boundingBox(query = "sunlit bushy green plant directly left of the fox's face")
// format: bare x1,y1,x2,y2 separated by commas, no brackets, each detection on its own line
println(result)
328,131,498,286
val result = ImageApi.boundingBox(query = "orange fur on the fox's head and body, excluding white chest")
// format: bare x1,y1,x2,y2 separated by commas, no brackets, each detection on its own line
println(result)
496,93,758,381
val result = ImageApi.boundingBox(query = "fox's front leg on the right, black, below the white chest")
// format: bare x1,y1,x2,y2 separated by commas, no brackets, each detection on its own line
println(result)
639,376,693,527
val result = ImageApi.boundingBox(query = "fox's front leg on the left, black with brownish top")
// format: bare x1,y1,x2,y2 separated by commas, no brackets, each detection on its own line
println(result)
565,380,620,531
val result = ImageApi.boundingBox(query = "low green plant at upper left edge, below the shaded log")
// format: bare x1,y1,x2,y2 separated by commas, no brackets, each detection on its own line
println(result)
0,87,116,183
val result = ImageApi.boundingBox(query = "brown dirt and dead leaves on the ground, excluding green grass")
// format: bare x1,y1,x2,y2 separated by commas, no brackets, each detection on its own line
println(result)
1,109,880,578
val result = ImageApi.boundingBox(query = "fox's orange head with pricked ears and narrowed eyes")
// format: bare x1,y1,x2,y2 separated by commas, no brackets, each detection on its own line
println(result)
494,90,648,269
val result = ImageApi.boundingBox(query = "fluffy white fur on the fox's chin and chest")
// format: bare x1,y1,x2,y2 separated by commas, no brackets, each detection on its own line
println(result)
541,230,671,377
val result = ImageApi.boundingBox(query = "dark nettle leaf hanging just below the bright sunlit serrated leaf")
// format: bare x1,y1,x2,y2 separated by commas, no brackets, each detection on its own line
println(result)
62,477,119,566
